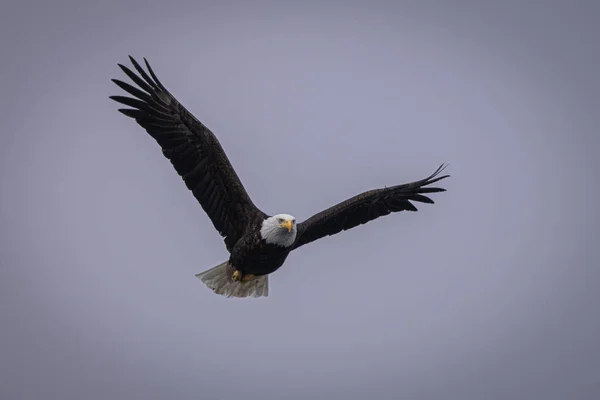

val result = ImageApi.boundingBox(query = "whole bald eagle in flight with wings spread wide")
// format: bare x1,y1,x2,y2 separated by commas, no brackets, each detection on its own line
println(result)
110,56,449,297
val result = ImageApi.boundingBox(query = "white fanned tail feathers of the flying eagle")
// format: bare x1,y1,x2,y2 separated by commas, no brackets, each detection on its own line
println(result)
196,261,269,297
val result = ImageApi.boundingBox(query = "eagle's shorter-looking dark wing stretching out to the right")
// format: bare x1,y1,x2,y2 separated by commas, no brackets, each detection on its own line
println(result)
294,164,449,249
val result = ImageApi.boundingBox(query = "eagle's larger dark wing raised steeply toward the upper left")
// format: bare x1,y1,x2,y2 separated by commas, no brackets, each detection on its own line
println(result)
110,56,263,251
